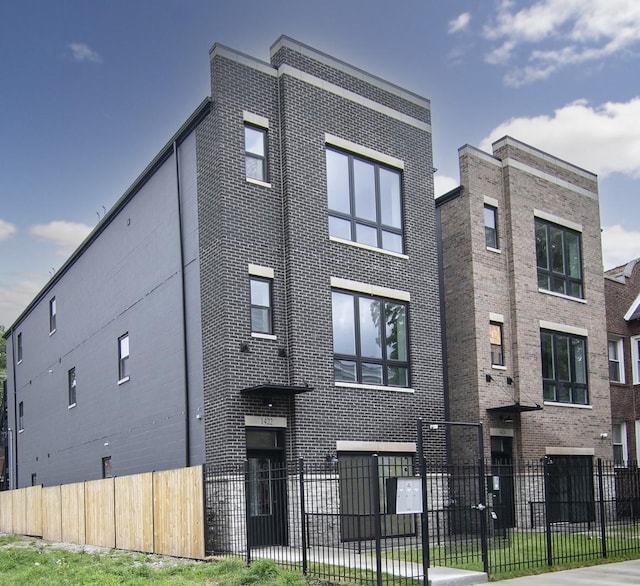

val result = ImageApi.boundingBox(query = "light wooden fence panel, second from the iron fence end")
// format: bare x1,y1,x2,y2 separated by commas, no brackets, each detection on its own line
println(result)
115,472,153,552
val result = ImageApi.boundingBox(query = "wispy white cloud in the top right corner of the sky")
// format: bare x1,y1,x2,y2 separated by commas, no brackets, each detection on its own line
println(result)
484,0,640,86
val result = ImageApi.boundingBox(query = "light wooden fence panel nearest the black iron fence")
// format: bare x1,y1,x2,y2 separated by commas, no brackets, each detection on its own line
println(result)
153,466,205,559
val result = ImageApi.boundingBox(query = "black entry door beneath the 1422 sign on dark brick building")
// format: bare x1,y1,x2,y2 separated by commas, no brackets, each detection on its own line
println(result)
246,426,287,546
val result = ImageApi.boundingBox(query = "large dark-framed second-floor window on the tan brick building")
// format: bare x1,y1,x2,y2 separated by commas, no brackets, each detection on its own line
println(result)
540,331,589,405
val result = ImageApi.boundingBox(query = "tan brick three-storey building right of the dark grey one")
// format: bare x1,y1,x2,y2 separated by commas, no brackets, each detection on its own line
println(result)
436,137,612,474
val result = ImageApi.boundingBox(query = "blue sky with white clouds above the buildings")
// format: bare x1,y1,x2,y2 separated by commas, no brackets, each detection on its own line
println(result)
0,0,640,326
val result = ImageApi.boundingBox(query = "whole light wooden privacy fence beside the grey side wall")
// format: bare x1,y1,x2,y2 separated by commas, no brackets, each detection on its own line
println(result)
0,466,205,559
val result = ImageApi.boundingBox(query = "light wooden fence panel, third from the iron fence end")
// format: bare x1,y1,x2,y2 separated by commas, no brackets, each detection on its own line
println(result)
84,478,116,547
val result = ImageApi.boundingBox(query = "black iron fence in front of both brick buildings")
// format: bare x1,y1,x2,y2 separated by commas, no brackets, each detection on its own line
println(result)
205,455,640,584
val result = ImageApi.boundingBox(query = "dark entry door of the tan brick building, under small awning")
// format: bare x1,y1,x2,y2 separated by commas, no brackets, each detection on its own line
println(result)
489,437,516,529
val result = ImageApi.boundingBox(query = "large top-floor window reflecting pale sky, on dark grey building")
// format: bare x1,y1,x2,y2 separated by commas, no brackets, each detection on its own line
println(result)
326,149,403,253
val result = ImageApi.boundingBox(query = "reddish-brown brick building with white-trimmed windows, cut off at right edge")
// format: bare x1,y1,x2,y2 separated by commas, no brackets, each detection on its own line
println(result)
605,259,640,467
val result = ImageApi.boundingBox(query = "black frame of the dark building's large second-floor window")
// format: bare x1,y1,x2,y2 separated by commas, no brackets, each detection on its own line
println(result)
331,289,411,389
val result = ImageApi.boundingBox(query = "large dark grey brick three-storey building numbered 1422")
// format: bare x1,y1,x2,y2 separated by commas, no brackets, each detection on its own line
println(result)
6,37,444,492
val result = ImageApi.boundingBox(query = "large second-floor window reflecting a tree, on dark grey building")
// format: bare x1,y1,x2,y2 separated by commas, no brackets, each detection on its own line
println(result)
332,291,409,387
